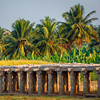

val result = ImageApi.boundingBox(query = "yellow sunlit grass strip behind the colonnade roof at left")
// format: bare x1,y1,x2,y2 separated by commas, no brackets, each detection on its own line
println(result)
0,60,51,65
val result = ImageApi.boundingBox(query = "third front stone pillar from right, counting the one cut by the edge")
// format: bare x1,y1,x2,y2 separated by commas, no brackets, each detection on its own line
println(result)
70,71,76,96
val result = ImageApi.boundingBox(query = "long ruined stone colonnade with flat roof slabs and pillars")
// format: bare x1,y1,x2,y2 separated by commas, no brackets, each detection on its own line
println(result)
0,63,100,96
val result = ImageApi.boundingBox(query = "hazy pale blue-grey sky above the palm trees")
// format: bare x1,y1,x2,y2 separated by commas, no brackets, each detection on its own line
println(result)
0,0,100,31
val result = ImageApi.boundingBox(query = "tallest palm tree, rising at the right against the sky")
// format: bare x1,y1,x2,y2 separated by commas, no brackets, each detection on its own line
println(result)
62,4,98,54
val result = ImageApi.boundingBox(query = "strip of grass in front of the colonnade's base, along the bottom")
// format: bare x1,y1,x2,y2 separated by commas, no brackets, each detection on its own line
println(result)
0,95,100,100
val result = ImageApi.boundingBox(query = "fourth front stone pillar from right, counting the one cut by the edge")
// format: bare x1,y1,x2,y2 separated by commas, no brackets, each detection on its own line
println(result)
57,71,64,95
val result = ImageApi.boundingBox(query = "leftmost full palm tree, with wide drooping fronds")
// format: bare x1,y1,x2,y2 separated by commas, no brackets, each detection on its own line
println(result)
3,19,39,59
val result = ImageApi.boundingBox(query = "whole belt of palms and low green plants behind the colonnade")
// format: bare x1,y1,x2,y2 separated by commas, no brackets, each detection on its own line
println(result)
0,4,100,63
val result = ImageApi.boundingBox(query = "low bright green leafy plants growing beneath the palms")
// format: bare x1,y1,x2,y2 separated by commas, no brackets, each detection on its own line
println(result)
0,45,100,64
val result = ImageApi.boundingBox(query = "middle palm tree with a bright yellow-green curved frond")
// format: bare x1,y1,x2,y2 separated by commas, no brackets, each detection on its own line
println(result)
33,17,67,56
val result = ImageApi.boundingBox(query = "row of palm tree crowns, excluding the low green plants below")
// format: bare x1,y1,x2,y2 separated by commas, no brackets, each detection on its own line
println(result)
0,4,100,59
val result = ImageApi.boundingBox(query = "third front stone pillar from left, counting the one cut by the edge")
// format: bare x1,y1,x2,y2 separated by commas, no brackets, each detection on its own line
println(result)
19,71,27,93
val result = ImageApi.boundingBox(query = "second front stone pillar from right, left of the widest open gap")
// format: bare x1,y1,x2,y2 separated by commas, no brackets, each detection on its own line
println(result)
82,71,90,96
